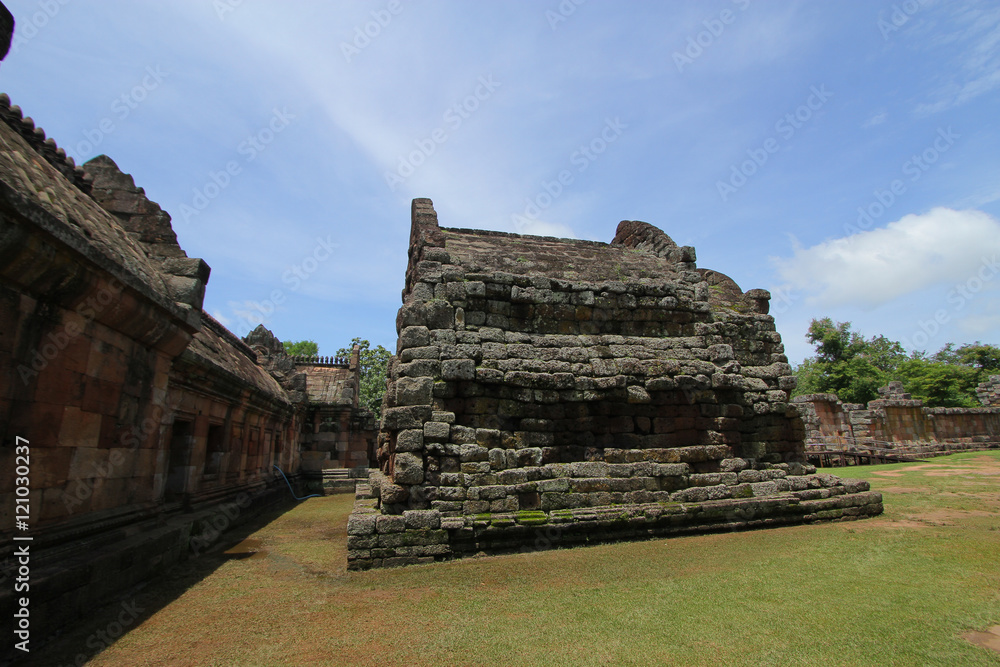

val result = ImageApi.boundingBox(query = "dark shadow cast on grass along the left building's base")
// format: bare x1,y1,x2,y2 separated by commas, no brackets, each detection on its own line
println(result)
10,497,299,667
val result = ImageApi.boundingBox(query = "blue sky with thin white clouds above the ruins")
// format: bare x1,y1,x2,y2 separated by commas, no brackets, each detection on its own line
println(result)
0,0,1000,363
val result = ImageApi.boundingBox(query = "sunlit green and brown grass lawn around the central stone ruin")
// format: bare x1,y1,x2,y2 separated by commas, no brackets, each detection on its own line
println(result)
33,452,1000,667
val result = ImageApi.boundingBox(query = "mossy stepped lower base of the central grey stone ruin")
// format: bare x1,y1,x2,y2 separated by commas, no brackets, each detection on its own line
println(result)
347,454,883,570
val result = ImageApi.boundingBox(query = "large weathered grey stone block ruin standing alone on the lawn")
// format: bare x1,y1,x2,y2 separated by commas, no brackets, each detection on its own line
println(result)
348,199,882,570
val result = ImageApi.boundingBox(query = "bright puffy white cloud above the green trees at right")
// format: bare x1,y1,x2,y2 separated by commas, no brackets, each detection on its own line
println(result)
771,208,1000,307
